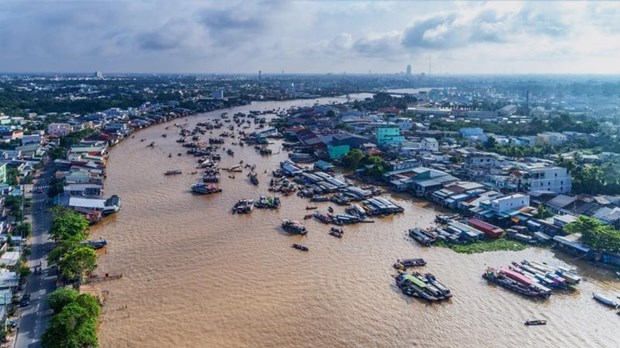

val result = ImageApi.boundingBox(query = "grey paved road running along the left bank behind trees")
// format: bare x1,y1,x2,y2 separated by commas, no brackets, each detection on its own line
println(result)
14,166,56,348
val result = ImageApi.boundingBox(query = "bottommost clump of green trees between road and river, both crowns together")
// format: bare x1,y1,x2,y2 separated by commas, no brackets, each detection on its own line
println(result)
41,289,101,348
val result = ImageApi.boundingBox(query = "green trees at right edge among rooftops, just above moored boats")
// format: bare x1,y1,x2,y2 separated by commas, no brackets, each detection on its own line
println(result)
564,216,620,252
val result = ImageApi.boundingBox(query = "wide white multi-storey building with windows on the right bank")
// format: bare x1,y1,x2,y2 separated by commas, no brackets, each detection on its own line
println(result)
520,167,572,193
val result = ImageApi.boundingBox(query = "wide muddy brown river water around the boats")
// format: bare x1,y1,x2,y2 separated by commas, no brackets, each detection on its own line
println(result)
92,99,620,348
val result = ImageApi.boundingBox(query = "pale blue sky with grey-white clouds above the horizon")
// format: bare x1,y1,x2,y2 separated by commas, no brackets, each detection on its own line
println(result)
0,0,620,74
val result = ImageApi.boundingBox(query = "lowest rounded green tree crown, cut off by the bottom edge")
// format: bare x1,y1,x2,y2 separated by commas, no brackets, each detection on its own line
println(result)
41,302,99,348
